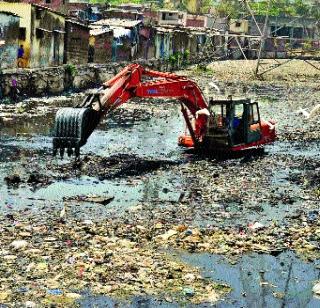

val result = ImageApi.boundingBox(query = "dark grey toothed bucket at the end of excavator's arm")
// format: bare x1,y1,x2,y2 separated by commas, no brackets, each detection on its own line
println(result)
53,107,101,157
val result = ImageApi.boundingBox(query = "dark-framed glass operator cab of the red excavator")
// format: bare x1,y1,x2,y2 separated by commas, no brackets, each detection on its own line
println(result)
203,99,262,152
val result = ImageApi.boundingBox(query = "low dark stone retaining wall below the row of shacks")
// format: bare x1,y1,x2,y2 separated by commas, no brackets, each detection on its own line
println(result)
0,54,218,102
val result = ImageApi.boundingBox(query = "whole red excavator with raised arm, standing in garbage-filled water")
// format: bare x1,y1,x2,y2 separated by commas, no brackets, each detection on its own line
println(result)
53,64,276,156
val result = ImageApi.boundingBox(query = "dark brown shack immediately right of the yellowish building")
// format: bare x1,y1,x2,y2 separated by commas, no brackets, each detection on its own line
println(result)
64,19,90,64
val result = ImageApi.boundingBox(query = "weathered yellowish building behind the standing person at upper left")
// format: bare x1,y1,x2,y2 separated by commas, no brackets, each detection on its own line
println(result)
0,2,65,67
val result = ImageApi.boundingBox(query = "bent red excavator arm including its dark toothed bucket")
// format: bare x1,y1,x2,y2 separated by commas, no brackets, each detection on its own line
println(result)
53,64,209,156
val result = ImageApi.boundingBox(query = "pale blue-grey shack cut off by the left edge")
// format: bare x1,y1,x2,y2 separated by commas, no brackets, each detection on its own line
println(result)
0,11,20,69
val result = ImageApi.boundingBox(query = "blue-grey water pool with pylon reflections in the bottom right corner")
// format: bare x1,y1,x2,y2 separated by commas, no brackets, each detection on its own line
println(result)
178,252,320,308
